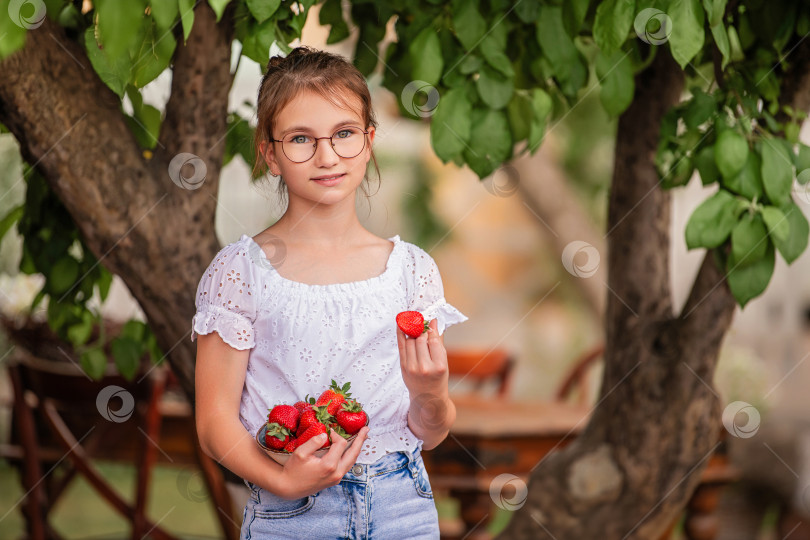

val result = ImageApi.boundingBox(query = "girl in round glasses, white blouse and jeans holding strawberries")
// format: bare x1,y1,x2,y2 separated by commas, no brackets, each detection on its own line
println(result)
191,47,467,540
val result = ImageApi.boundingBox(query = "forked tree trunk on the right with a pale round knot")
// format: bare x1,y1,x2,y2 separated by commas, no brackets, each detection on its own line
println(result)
501,50,735,540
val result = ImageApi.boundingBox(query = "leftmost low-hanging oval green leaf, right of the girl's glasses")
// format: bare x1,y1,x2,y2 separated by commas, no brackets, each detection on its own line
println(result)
430,88,472,163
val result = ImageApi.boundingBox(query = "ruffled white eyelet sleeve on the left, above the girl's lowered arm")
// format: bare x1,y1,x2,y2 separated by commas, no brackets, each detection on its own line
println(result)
191,242,259,350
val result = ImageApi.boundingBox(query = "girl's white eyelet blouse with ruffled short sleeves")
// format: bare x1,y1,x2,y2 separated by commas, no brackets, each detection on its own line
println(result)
191,234,467,464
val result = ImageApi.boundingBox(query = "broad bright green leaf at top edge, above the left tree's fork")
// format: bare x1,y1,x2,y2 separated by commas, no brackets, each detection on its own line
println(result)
95,0,146,61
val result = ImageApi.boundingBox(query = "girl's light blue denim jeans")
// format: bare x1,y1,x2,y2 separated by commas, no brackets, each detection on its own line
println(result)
241,448,439,540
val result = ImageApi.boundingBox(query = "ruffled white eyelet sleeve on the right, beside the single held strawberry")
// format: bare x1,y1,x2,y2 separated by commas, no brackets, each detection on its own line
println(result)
406,245,468,335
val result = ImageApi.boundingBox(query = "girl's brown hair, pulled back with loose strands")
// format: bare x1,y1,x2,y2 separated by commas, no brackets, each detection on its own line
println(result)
253,46,380,206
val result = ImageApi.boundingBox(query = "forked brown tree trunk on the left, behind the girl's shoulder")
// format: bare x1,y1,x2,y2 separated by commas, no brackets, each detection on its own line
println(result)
0,2,233,403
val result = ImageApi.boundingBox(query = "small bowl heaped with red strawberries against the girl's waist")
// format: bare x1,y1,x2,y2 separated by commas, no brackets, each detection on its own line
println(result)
256,379,368,465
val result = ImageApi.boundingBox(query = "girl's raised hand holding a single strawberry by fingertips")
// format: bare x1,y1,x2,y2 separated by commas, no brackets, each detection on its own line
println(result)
397,319,450,400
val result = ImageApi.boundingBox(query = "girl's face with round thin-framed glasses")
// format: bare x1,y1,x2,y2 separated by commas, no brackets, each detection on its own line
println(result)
262,88,374,204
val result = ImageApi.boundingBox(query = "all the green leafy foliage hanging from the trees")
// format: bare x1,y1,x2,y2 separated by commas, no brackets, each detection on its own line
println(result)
0,0,810,382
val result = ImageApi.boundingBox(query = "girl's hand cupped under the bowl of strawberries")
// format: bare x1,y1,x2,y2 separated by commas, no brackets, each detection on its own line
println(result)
275,426,368,499
